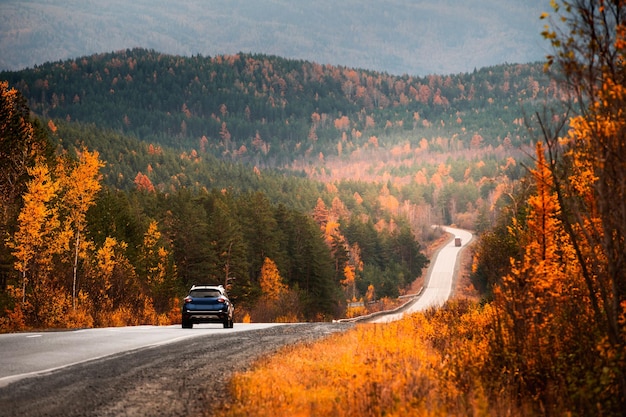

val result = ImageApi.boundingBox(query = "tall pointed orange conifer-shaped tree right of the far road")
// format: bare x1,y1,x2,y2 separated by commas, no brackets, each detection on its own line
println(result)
489,142,594,408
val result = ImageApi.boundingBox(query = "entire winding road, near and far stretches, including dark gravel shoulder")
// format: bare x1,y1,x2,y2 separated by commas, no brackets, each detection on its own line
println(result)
0,227,472,417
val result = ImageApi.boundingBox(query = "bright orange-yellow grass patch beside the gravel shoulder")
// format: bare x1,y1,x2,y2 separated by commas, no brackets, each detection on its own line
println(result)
222,304,502,417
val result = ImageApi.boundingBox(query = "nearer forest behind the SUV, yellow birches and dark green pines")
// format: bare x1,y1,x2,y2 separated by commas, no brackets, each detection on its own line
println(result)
0,75,427,324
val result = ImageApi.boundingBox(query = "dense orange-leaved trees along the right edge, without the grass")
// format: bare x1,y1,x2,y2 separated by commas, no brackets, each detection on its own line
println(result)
476,0,626,415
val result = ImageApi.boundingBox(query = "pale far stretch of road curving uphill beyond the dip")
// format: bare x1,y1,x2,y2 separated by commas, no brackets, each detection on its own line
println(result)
370,226,472,323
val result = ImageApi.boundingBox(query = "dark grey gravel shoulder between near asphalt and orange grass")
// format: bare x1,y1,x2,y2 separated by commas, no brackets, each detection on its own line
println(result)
0,323,354,417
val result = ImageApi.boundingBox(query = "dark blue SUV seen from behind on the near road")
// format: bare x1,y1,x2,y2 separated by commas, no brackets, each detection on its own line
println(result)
182,285,235,329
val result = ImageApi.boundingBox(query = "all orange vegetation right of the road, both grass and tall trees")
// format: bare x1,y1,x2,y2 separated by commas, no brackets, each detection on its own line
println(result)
220,1,626,416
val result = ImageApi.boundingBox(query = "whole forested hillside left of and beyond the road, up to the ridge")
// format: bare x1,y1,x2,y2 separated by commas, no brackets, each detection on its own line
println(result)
0,49,560,327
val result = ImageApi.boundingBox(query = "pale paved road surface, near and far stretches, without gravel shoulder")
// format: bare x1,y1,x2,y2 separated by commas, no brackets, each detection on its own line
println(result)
0,227,472,387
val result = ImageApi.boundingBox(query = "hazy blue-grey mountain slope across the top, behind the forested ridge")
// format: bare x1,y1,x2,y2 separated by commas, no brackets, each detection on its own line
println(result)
0,0,549,75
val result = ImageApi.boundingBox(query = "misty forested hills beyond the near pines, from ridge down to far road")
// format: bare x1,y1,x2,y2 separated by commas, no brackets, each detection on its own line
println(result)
0,49,562,227
